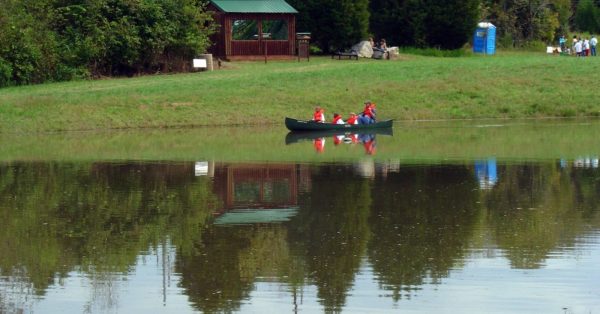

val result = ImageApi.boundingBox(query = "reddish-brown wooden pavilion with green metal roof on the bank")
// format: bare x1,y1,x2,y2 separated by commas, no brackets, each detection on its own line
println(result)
208,0,298,60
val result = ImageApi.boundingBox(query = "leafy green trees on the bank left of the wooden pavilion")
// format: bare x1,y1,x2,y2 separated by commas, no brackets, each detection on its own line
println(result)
0,0,215,87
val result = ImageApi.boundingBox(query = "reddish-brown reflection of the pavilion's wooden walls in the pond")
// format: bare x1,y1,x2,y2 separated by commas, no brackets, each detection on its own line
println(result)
214,164,298,214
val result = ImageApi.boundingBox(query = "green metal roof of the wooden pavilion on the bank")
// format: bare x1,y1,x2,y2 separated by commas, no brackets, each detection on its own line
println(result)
210,0,298,13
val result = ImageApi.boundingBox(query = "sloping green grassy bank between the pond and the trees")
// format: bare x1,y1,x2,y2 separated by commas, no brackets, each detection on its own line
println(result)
0,53,600,133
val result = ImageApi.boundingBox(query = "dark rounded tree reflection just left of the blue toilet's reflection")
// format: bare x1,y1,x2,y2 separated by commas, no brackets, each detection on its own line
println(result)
368,166,479,301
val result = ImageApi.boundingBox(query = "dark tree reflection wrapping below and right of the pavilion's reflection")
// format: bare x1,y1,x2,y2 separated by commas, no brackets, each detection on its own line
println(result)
177,166,371,312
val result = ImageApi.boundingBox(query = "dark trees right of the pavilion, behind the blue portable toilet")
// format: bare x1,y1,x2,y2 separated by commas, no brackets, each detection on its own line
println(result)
289,0,600,51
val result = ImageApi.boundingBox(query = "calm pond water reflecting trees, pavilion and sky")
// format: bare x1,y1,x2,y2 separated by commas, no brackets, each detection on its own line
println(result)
0,121,600,313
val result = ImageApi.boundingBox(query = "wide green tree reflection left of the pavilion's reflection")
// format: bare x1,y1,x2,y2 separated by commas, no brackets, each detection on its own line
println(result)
0,163,217,312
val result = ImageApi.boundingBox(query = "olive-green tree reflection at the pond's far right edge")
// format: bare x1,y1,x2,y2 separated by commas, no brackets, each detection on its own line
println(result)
483,164,600,269
